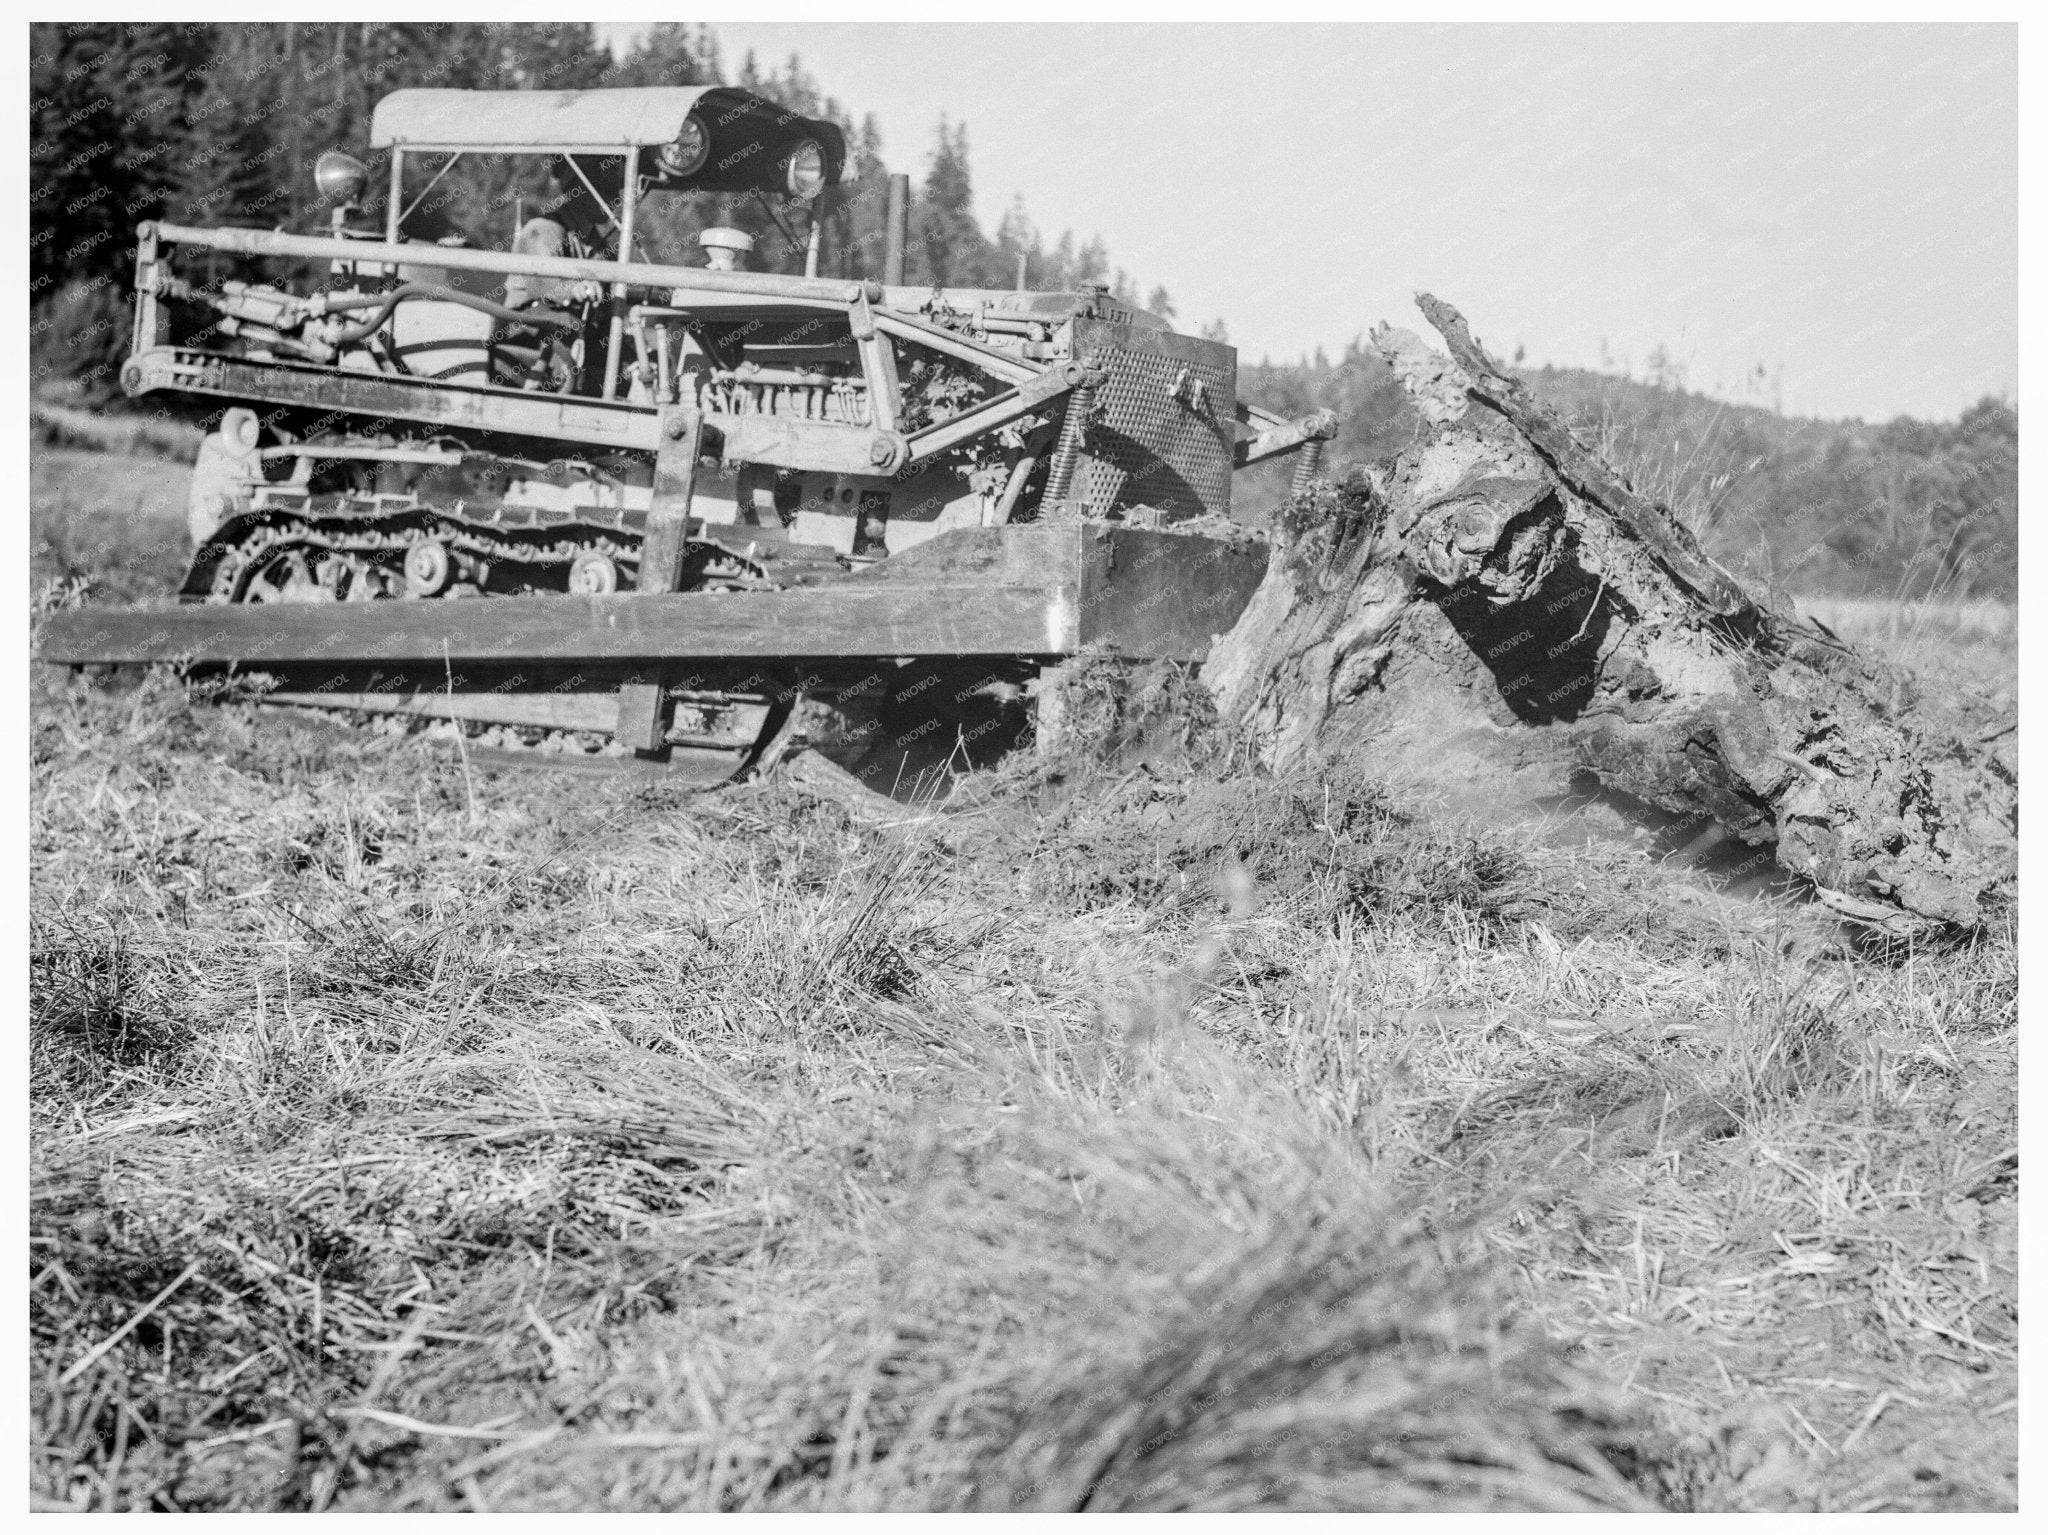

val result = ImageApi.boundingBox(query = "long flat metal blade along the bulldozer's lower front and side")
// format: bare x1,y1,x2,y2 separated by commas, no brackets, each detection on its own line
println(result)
39,524,1266,667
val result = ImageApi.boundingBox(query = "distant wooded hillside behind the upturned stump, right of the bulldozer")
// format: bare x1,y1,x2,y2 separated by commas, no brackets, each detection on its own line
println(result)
1239,342,2019,600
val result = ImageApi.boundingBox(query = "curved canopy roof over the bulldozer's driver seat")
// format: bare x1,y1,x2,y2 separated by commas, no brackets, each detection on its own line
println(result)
371,86,846,190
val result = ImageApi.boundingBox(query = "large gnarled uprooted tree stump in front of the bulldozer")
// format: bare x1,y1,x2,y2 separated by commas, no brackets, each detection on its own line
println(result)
1204,295,2017,935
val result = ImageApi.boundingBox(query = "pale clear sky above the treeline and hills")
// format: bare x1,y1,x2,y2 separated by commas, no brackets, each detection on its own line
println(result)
600,20,2019,420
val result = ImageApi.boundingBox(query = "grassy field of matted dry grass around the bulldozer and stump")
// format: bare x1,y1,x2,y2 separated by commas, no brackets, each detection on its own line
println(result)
31,448,2017,1510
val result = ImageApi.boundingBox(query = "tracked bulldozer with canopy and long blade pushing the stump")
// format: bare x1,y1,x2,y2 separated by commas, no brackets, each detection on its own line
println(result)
39,86,1335,782
